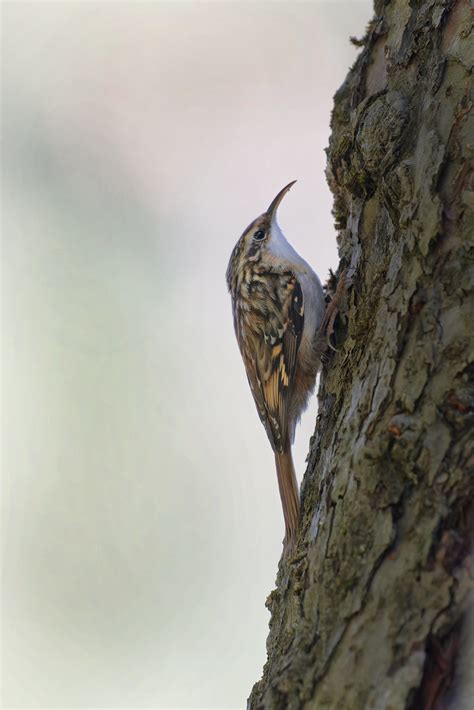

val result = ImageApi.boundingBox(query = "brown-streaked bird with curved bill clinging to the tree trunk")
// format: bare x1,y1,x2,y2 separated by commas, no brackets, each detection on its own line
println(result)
226,180,333,549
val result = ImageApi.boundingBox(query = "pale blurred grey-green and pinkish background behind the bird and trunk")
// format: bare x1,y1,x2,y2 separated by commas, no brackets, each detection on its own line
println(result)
1,0,371,708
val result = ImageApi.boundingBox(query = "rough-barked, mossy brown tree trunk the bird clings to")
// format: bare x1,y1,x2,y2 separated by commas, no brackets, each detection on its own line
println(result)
249,0,474,710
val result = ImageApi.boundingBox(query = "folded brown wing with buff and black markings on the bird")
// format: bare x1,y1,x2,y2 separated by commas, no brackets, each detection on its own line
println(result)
239,272,304,452
